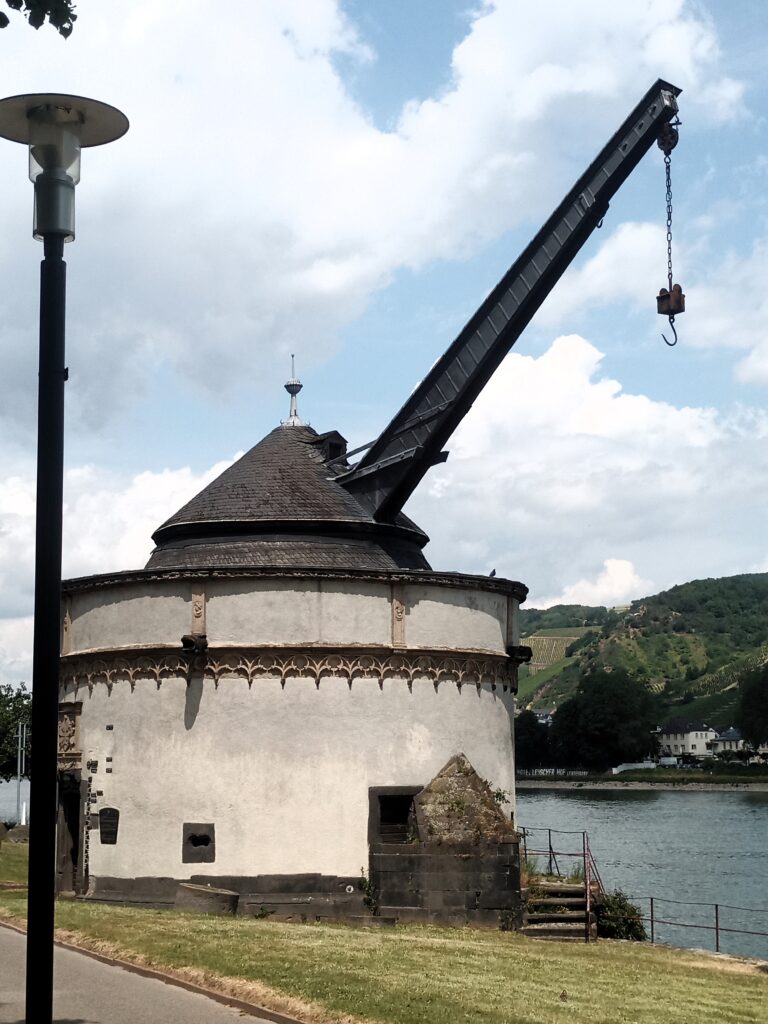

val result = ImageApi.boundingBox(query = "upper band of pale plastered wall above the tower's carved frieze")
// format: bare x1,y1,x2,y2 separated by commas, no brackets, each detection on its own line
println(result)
63,579,514,654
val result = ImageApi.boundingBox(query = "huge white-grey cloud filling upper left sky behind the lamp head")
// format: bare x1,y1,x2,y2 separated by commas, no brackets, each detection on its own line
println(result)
0,0,740,436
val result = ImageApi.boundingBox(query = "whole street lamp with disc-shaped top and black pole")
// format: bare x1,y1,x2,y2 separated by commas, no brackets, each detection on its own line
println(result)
0,93,128,1024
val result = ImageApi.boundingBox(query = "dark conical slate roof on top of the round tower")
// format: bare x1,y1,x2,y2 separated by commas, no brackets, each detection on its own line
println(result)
146,424,429,569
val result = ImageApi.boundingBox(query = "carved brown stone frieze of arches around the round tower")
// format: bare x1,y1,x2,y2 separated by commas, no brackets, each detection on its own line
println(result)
61,648,515,691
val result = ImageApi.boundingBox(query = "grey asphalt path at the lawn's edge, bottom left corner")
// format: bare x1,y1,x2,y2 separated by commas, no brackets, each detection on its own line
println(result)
0,928,274,1024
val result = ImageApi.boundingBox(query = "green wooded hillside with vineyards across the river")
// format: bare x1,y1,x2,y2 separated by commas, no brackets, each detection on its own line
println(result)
519,573,768,726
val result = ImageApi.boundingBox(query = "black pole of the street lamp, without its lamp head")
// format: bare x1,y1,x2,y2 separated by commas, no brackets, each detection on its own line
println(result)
27,232,67,1024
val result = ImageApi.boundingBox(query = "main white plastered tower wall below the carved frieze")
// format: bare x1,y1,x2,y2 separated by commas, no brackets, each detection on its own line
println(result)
73,678,514,878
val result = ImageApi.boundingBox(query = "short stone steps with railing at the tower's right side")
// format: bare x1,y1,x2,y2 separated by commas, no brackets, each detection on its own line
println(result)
521,882,600,942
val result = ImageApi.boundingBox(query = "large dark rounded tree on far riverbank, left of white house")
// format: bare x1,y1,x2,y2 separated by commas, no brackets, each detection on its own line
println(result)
550,670,658,770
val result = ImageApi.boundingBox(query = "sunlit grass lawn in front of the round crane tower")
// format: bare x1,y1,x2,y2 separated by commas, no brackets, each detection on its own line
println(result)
0,892,768,1024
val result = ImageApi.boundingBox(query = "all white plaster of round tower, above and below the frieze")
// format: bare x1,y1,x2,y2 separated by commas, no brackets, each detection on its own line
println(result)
62,577,517,879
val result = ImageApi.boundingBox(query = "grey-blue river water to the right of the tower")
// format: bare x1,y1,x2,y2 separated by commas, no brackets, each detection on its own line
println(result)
517,790,768,959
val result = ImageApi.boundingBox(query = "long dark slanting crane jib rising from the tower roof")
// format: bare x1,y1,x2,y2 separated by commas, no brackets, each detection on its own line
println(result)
336,79,681,521
